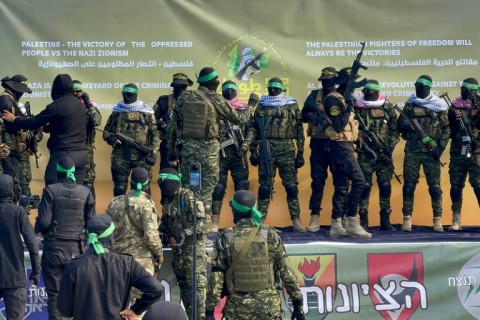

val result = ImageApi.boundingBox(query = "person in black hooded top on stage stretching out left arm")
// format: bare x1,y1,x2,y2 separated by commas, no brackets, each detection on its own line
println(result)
2,74,87,186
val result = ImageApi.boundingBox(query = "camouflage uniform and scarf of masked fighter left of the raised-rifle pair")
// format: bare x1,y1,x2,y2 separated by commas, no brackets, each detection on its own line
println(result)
248,95,305,221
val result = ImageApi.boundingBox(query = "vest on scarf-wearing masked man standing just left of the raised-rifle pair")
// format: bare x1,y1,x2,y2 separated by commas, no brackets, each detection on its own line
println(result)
258,104,297,139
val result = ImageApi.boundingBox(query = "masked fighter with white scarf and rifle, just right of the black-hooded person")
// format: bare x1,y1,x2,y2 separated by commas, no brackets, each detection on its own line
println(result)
103,83,160,197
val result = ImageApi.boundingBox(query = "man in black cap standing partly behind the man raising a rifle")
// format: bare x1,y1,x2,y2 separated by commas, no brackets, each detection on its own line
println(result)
302,67,337,232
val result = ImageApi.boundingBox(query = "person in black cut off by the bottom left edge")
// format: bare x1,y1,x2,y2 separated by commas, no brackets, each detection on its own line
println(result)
0,174,40,320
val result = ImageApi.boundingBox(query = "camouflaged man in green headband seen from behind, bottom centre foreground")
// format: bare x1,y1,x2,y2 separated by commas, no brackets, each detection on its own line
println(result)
205,190,305,320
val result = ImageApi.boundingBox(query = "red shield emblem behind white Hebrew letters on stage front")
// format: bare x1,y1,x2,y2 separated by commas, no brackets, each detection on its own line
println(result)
368,253,427,320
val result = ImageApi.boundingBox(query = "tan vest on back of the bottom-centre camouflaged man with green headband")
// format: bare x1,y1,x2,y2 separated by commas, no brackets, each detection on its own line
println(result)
224,227,275,294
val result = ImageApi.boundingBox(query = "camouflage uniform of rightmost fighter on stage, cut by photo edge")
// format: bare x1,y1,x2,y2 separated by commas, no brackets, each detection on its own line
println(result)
448,90,480,230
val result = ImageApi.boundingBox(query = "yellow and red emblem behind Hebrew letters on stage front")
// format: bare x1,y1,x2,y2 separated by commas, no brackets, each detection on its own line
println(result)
284,254,337,319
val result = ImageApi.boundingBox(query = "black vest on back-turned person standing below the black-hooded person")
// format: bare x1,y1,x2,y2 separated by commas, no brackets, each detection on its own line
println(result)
45,183,90,240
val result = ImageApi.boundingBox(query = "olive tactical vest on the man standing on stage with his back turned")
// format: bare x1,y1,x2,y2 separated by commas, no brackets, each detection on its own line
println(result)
180,90,220,139
